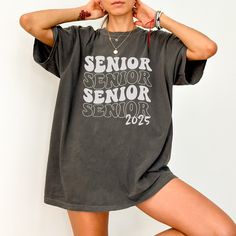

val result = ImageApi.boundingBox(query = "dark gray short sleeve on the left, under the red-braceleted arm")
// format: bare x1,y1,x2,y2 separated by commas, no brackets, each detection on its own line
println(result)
33,25,82,78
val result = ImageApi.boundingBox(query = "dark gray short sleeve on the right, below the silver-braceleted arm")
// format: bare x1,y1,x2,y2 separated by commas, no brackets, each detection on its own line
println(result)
165,32,207,85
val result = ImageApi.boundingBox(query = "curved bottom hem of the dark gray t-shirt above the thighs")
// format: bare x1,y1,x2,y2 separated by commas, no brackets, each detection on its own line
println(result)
44,172,178,212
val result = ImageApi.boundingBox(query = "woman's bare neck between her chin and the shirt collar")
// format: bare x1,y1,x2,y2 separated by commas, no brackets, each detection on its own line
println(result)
106,15,136,32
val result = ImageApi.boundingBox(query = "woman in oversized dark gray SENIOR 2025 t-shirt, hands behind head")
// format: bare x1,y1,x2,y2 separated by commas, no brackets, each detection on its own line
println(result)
20,0,236,236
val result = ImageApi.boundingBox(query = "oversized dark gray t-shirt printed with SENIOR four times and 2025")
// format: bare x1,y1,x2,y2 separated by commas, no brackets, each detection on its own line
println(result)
33,25,206,211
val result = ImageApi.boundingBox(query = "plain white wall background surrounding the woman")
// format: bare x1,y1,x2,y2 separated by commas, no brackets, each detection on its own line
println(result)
0,0,236,236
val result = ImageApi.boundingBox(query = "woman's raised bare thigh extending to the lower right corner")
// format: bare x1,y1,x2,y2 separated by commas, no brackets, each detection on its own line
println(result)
136,178,236,236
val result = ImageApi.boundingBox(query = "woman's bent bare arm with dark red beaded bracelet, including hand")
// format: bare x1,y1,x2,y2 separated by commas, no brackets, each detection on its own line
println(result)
19,0,104,47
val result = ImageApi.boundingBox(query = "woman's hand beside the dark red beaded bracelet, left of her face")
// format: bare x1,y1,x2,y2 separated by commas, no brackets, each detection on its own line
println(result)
81,0,107,20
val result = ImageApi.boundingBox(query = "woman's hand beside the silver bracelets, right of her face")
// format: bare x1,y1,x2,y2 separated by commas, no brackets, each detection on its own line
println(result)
133,0,156,28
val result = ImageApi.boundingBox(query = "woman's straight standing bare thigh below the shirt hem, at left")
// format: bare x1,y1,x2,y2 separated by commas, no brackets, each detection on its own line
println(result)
67,210,109,236
